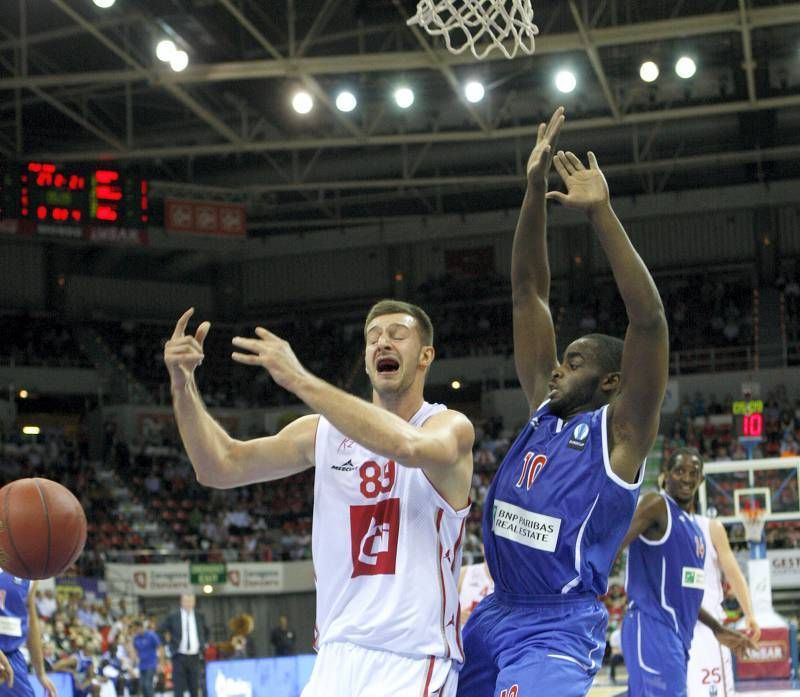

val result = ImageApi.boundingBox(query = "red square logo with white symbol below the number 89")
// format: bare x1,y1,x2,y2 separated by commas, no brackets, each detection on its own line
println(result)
350,498,400,578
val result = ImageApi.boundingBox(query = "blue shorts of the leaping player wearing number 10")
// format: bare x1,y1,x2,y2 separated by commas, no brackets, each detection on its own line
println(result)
457,592,608,697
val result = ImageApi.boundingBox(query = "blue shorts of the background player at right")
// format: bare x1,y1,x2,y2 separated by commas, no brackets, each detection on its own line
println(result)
622,608,689,697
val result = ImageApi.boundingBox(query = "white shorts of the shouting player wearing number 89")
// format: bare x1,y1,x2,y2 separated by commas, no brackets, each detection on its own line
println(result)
301,642,458,697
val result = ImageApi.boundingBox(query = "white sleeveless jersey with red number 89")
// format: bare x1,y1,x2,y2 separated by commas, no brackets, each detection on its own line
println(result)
312,402,469,662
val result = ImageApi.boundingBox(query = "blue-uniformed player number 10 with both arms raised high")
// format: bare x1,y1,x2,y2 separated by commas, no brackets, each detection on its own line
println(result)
458,108,669,697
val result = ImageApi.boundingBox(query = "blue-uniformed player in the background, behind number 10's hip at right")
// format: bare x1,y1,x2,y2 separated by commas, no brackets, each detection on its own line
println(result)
622,448,755,697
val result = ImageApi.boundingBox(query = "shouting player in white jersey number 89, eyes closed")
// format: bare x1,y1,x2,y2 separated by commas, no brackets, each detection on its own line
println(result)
164,300,475,697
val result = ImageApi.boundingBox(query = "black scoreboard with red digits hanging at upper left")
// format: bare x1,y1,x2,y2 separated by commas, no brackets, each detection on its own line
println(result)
0,162,150,228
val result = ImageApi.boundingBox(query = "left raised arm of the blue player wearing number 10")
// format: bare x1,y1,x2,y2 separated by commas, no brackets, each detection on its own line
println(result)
511,107,564,412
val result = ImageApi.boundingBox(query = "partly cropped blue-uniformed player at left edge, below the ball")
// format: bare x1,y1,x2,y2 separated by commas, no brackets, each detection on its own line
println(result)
0,570,56,697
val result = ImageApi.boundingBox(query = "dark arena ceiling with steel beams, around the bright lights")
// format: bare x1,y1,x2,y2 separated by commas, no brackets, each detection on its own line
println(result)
0,0,800,234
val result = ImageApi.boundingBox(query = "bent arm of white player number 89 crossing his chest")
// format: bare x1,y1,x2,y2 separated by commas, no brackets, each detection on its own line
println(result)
233,327,475,508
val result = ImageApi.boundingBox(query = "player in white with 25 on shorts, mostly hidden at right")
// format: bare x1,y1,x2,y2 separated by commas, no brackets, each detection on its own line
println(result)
686,515,761,697
